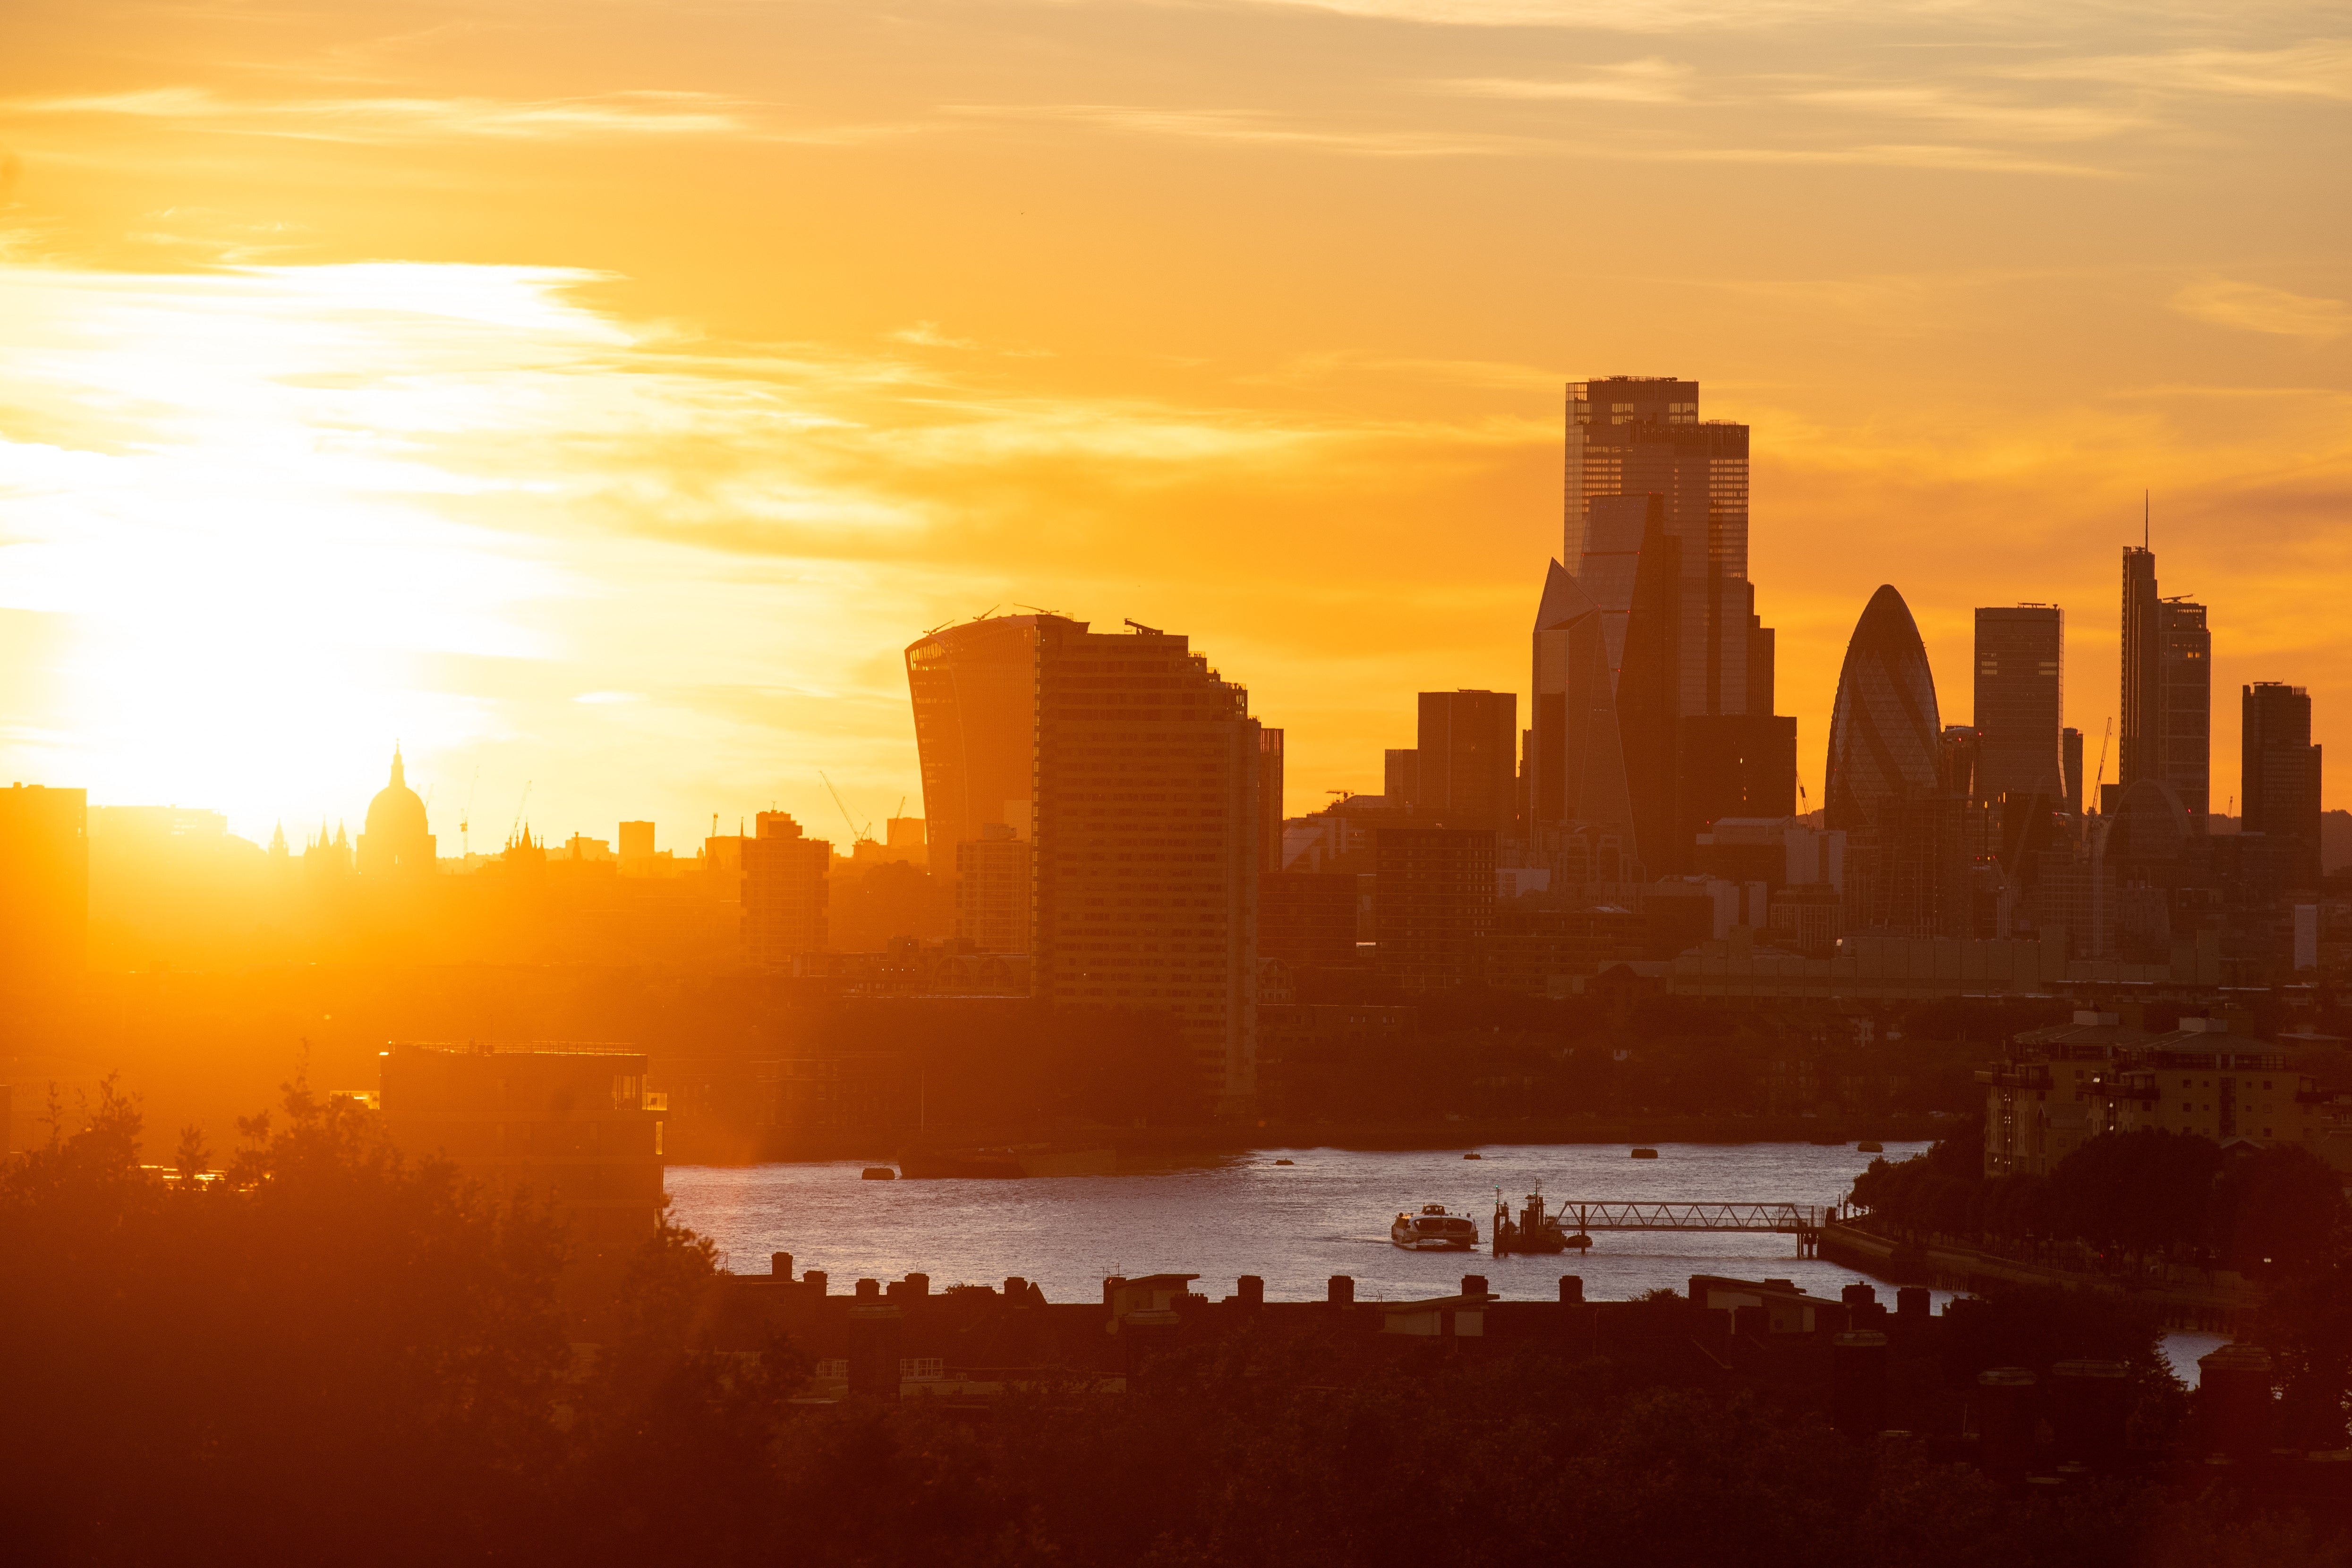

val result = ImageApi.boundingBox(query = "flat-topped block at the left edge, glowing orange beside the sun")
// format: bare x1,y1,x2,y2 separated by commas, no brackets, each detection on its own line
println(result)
0,783,89,1020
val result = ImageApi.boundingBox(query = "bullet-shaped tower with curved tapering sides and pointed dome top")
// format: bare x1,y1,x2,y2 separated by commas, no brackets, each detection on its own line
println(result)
1823,583,1966,936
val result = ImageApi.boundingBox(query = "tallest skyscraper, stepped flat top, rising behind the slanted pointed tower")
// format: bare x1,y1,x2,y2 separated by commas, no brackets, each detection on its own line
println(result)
1559,376,1771,715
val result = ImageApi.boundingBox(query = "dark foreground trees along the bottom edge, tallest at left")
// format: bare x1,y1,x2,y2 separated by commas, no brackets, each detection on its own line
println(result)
0,1086,2352,1568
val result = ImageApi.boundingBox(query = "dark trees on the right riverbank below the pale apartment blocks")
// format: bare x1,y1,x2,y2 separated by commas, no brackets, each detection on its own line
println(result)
1853,1119,2352,1441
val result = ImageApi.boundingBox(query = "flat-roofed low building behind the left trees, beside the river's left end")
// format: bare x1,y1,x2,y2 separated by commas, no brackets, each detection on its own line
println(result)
379,1041,663,1255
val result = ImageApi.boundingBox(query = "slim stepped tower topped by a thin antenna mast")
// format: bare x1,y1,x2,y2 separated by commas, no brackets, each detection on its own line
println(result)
2117,545,2213,832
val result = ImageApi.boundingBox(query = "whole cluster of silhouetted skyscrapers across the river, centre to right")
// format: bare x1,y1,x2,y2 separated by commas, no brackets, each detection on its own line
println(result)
908,376,2319,1107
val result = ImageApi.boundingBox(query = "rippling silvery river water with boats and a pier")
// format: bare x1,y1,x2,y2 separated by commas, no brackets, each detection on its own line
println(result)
668,1142,1926,1300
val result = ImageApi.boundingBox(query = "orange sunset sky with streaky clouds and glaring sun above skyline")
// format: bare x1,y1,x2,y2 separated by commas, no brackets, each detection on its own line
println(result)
0,0,2352,853
